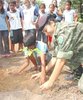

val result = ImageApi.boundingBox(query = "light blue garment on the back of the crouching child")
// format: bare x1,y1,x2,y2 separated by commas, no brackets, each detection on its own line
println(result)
36,41,48,54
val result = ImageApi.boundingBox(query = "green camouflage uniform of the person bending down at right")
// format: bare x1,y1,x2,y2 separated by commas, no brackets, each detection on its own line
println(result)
53,23,83,93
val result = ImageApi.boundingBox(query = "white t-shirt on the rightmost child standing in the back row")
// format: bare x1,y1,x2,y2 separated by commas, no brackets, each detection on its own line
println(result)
63,10,75,23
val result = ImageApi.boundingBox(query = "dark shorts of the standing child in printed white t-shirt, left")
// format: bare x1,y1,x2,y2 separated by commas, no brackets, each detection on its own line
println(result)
10,29,23,44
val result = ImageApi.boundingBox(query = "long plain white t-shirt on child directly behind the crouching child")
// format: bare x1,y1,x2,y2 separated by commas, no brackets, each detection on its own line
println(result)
22,7,36,30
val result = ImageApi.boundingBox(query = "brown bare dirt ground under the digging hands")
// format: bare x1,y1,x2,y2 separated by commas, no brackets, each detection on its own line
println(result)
0,53,83,100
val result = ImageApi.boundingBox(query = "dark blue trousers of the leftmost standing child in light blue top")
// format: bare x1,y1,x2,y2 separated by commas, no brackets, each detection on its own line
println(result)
0,30,9,54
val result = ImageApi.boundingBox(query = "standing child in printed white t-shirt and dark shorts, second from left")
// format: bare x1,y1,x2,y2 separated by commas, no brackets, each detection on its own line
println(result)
7,1,23,52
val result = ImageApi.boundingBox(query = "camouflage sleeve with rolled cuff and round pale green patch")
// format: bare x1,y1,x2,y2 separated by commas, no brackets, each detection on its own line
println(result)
57,25,76,59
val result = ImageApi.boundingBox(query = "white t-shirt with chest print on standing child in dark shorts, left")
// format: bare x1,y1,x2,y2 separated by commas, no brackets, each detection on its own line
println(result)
7,10,22,30
